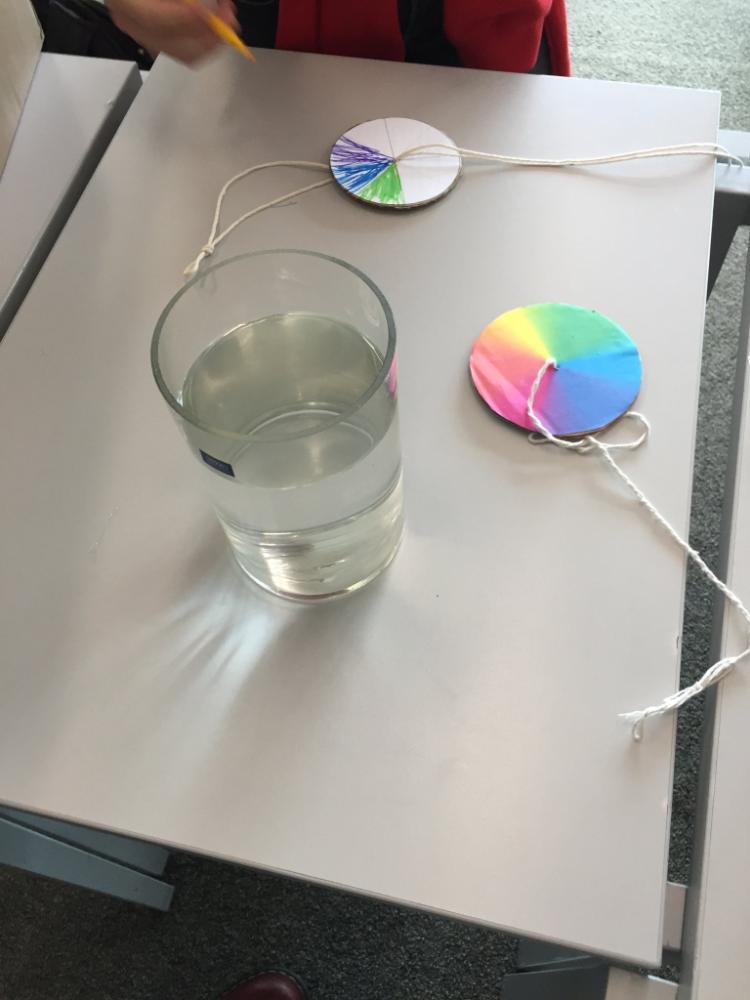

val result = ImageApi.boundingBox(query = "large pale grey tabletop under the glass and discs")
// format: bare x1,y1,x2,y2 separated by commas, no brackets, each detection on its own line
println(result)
0,52,719,963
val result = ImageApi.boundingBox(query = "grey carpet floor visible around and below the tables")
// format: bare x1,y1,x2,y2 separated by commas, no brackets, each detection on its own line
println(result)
0,0,750,1000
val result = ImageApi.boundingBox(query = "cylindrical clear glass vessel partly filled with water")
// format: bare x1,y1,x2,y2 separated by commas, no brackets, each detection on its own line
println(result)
151,250,403,600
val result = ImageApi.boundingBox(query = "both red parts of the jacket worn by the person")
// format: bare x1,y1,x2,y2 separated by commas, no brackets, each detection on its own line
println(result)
276,0,570,76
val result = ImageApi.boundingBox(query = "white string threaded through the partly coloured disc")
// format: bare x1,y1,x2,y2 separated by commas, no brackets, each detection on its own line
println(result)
184,142,744,276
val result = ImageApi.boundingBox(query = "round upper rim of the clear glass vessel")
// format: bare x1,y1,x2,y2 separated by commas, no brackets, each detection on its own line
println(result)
151,248,396,445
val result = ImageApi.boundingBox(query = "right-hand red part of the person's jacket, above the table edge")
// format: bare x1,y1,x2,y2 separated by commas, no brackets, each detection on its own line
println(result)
444,0,570,76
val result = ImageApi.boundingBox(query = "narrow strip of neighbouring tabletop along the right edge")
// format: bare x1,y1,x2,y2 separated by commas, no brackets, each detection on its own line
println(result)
681,246,750,1000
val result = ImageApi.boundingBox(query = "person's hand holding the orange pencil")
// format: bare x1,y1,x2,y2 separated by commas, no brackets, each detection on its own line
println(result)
107,0,239,63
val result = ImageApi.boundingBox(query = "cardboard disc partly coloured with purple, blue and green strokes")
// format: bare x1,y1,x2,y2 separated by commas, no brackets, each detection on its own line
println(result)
331,118,461,208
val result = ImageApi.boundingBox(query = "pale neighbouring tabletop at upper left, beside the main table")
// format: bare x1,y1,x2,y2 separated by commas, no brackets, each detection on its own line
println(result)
0,52,140,337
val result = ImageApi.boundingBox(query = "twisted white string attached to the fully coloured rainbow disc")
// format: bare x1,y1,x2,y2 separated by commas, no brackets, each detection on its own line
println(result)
527,358,750,740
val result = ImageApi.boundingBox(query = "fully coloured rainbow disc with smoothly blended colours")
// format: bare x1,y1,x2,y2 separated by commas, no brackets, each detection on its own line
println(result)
469,303,642,437
